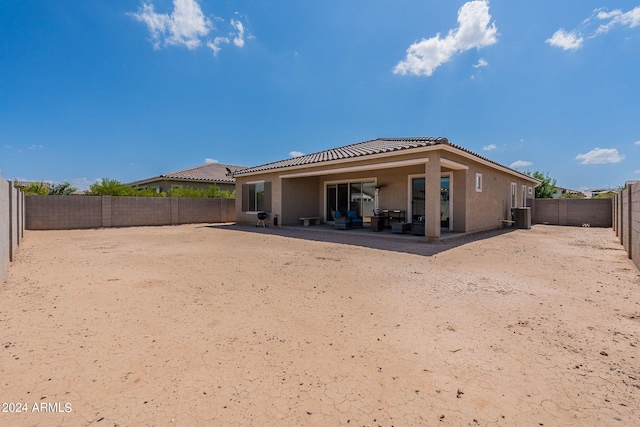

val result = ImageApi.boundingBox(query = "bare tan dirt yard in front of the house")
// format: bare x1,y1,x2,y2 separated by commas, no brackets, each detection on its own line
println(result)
0,225,640,426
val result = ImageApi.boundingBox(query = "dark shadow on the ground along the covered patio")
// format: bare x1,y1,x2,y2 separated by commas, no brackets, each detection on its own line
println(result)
202,224,515,256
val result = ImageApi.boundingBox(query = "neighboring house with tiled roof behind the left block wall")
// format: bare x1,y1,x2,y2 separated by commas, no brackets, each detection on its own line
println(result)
126,163,245,193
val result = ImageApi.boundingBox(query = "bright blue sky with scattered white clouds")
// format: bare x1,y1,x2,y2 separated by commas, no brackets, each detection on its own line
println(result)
0,0,640,189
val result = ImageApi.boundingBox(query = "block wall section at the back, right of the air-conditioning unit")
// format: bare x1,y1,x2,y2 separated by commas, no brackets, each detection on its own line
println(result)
531,199,613,227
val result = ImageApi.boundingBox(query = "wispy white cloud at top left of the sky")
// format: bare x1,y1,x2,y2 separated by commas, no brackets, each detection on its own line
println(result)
129,0,245,56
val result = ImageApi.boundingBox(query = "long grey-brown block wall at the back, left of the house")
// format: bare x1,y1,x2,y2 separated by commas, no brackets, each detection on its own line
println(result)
25,196,235,230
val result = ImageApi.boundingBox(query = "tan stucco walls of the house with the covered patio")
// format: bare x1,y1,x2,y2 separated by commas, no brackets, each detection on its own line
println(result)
236,152,534,232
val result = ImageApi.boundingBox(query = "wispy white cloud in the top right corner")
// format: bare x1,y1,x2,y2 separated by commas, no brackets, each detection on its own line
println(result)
546,6,640,50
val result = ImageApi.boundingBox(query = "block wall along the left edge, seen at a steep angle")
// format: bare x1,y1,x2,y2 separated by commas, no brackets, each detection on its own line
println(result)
0,178,25,280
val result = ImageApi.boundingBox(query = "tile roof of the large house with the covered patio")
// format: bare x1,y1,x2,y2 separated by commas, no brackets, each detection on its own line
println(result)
234,137,539,182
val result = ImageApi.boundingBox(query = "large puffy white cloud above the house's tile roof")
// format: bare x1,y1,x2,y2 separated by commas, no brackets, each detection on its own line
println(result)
393,0,498,77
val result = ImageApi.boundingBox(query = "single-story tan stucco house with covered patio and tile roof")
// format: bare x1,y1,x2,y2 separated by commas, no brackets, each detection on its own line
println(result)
233,137,540,240
